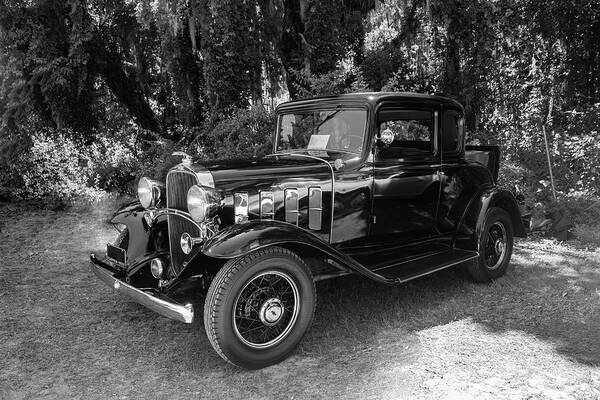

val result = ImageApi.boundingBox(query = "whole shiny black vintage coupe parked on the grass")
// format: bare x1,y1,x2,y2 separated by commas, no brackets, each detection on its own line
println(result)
91,93,525,368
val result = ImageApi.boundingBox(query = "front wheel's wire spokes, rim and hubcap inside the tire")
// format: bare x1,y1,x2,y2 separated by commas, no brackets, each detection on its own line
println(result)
233,270,300,349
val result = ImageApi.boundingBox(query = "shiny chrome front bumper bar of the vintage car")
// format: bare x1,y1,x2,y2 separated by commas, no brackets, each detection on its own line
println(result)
90,254,194,324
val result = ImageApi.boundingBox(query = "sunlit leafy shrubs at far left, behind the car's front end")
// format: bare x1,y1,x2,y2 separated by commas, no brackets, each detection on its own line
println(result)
0,127,184,206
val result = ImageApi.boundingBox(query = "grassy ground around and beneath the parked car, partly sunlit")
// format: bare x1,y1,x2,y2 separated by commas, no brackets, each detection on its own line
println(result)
0,206,600,399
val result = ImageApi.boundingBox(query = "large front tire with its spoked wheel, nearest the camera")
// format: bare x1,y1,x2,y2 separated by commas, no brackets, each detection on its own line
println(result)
204,247,316,369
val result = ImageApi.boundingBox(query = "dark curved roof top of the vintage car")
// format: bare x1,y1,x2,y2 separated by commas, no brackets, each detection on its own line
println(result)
276,92,462,112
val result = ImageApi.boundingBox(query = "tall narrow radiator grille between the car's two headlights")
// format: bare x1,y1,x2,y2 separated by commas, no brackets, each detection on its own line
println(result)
167,171,200,274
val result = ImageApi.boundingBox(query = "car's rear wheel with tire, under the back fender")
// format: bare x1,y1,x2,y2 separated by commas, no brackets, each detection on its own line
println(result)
467,207,514,283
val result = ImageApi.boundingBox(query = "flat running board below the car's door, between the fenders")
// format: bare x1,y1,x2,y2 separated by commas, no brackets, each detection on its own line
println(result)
372,248,479,283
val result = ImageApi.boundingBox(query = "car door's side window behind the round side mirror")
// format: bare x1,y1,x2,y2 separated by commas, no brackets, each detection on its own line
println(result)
378,109,434,159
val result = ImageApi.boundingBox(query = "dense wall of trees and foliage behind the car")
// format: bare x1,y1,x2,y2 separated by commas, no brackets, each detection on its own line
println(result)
0,0,600,235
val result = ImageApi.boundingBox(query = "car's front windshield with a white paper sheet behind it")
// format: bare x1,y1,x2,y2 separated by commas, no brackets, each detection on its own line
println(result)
276,110,367,153
